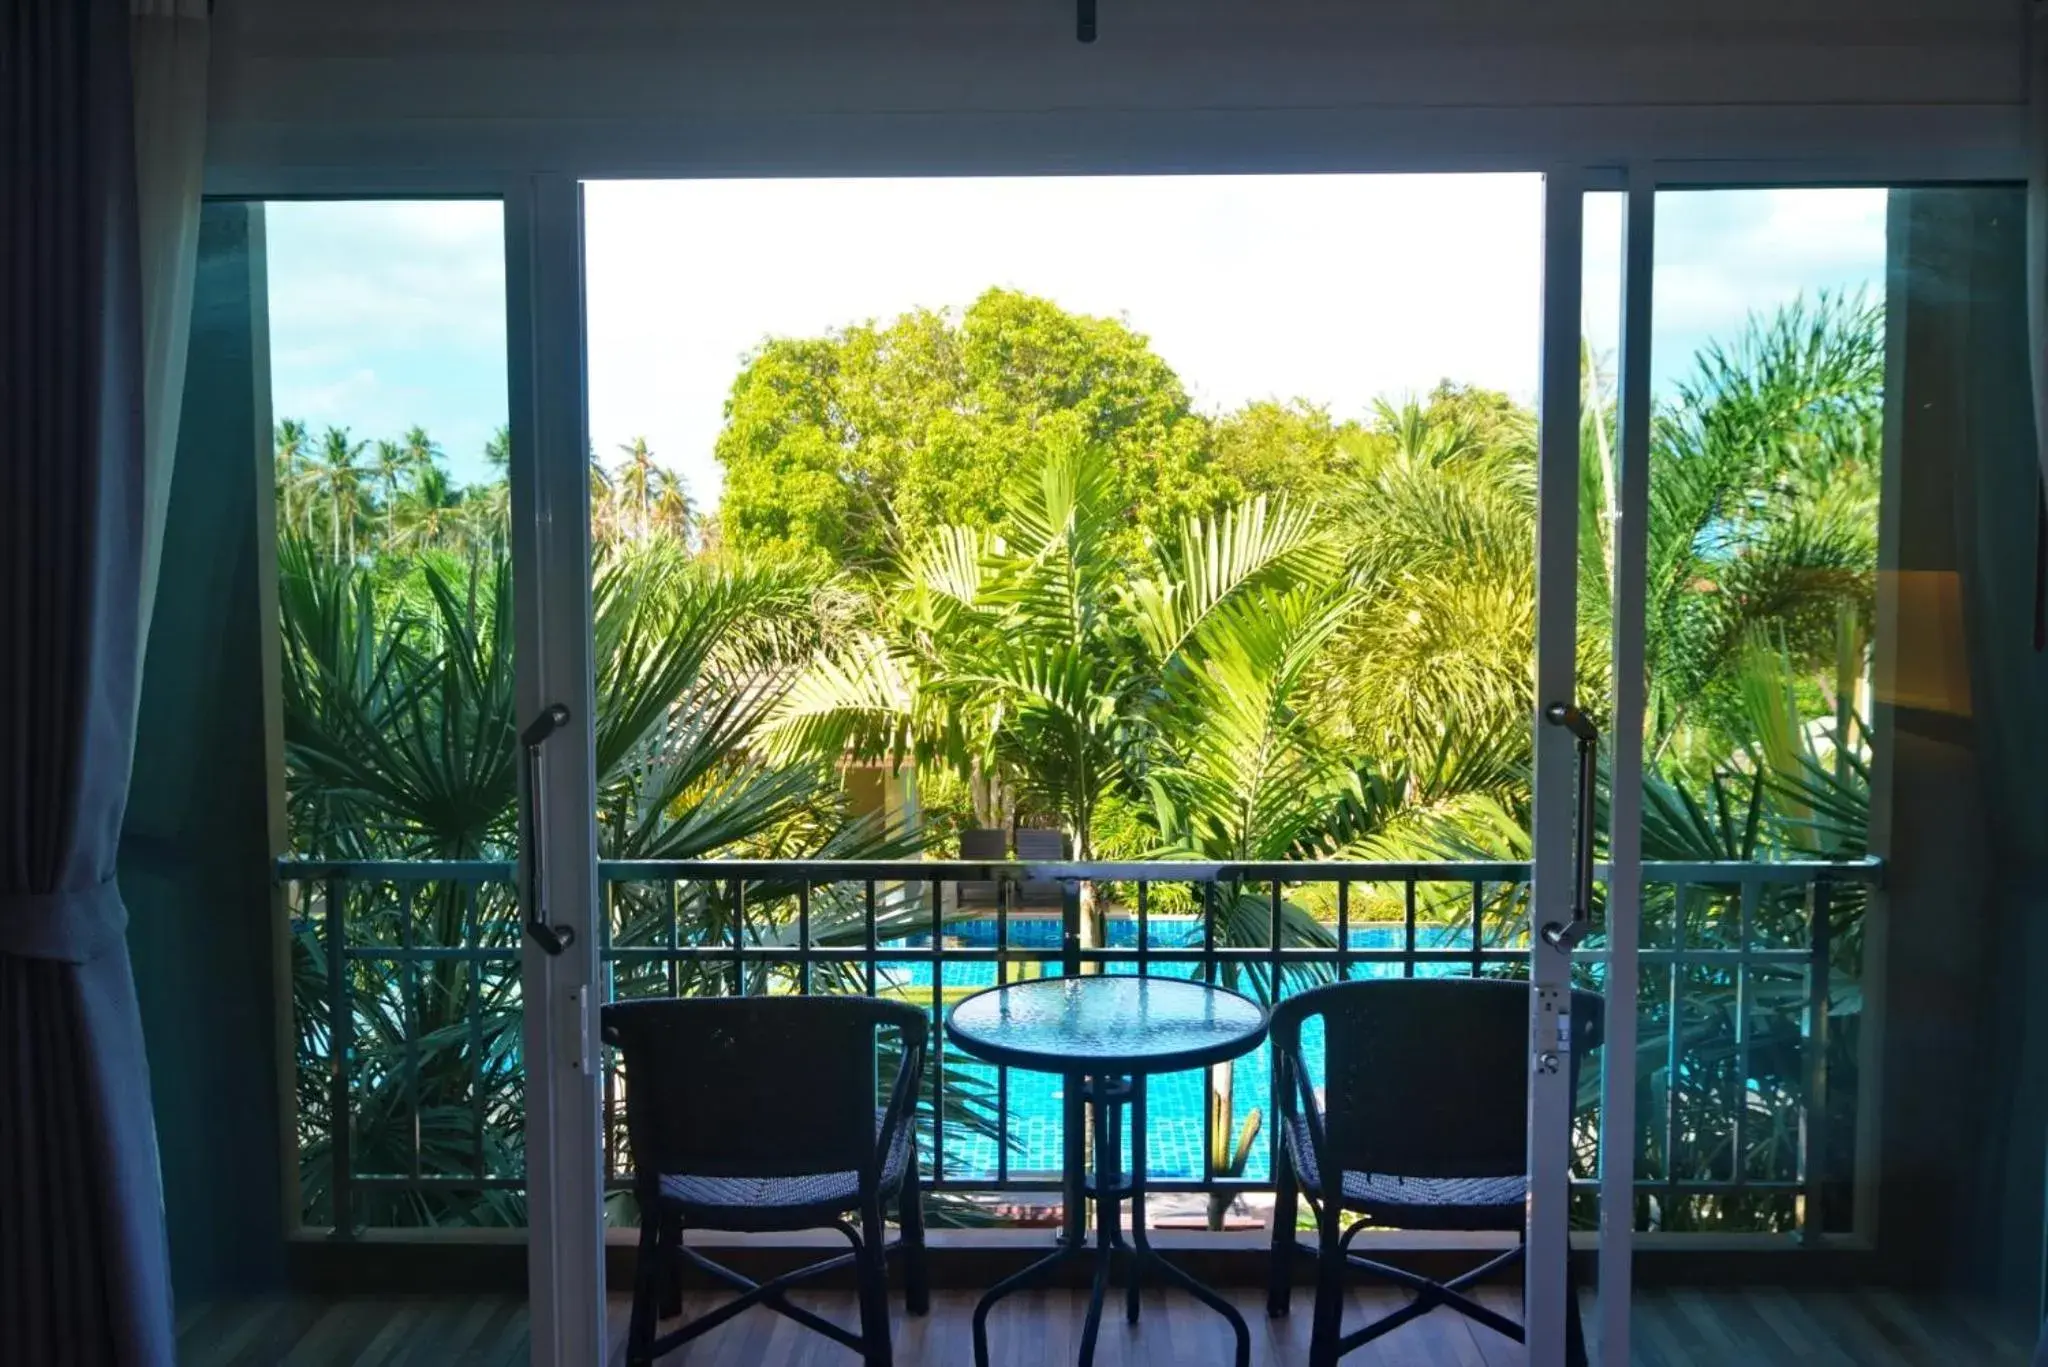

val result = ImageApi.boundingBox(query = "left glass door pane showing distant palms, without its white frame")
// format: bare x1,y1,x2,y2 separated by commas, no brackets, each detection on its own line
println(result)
254,201,526,1240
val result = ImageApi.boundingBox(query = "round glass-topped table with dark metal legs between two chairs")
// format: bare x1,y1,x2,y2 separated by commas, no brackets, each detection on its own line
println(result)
946,974,1266,1367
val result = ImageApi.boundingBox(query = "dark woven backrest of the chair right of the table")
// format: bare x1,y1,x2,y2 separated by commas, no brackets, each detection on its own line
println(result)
1272,978,1602,1176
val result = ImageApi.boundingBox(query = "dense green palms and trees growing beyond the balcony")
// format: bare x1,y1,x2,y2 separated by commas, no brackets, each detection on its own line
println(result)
276,282,1882,1228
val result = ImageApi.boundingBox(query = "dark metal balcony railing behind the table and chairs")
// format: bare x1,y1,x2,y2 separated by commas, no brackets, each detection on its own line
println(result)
279,861,1878,1242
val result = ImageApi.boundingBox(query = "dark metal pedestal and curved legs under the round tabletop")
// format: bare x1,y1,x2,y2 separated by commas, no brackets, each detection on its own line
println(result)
975,1074,1251,1367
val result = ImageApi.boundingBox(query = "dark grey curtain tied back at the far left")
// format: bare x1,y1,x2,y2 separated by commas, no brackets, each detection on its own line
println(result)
0,0,174,1367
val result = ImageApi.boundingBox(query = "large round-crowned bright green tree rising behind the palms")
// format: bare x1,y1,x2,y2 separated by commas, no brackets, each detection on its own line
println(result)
717,289,1229,570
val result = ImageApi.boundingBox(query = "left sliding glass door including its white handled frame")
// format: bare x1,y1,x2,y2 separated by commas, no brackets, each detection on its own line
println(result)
252,180,604,1363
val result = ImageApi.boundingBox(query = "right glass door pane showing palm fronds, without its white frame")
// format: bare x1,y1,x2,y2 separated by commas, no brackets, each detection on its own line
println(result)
1636,189,1888,1238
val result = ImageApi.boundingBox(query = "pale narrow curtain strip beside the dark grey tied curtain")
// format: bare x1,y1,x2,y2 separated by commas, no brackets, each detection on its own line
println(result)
131,0,209,664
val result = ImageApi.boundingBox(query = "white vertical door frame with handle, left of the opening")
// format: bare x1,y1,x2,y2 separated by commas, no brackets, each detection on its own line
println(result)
506,174,604,1367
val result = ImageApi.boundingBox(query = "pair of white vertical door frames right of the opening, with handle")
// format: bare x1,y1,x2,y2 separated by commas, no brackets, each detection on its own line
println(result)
1524,166,1657,1367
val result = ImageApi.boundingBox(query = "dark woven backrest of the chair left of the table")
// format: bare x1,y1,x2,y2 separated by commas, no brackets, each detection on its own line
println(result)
604,996,928,1183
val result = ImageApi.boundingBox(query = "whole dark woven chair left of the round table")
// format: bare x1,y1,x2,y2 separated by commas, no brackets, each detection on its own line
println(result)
604,996,930,1367
